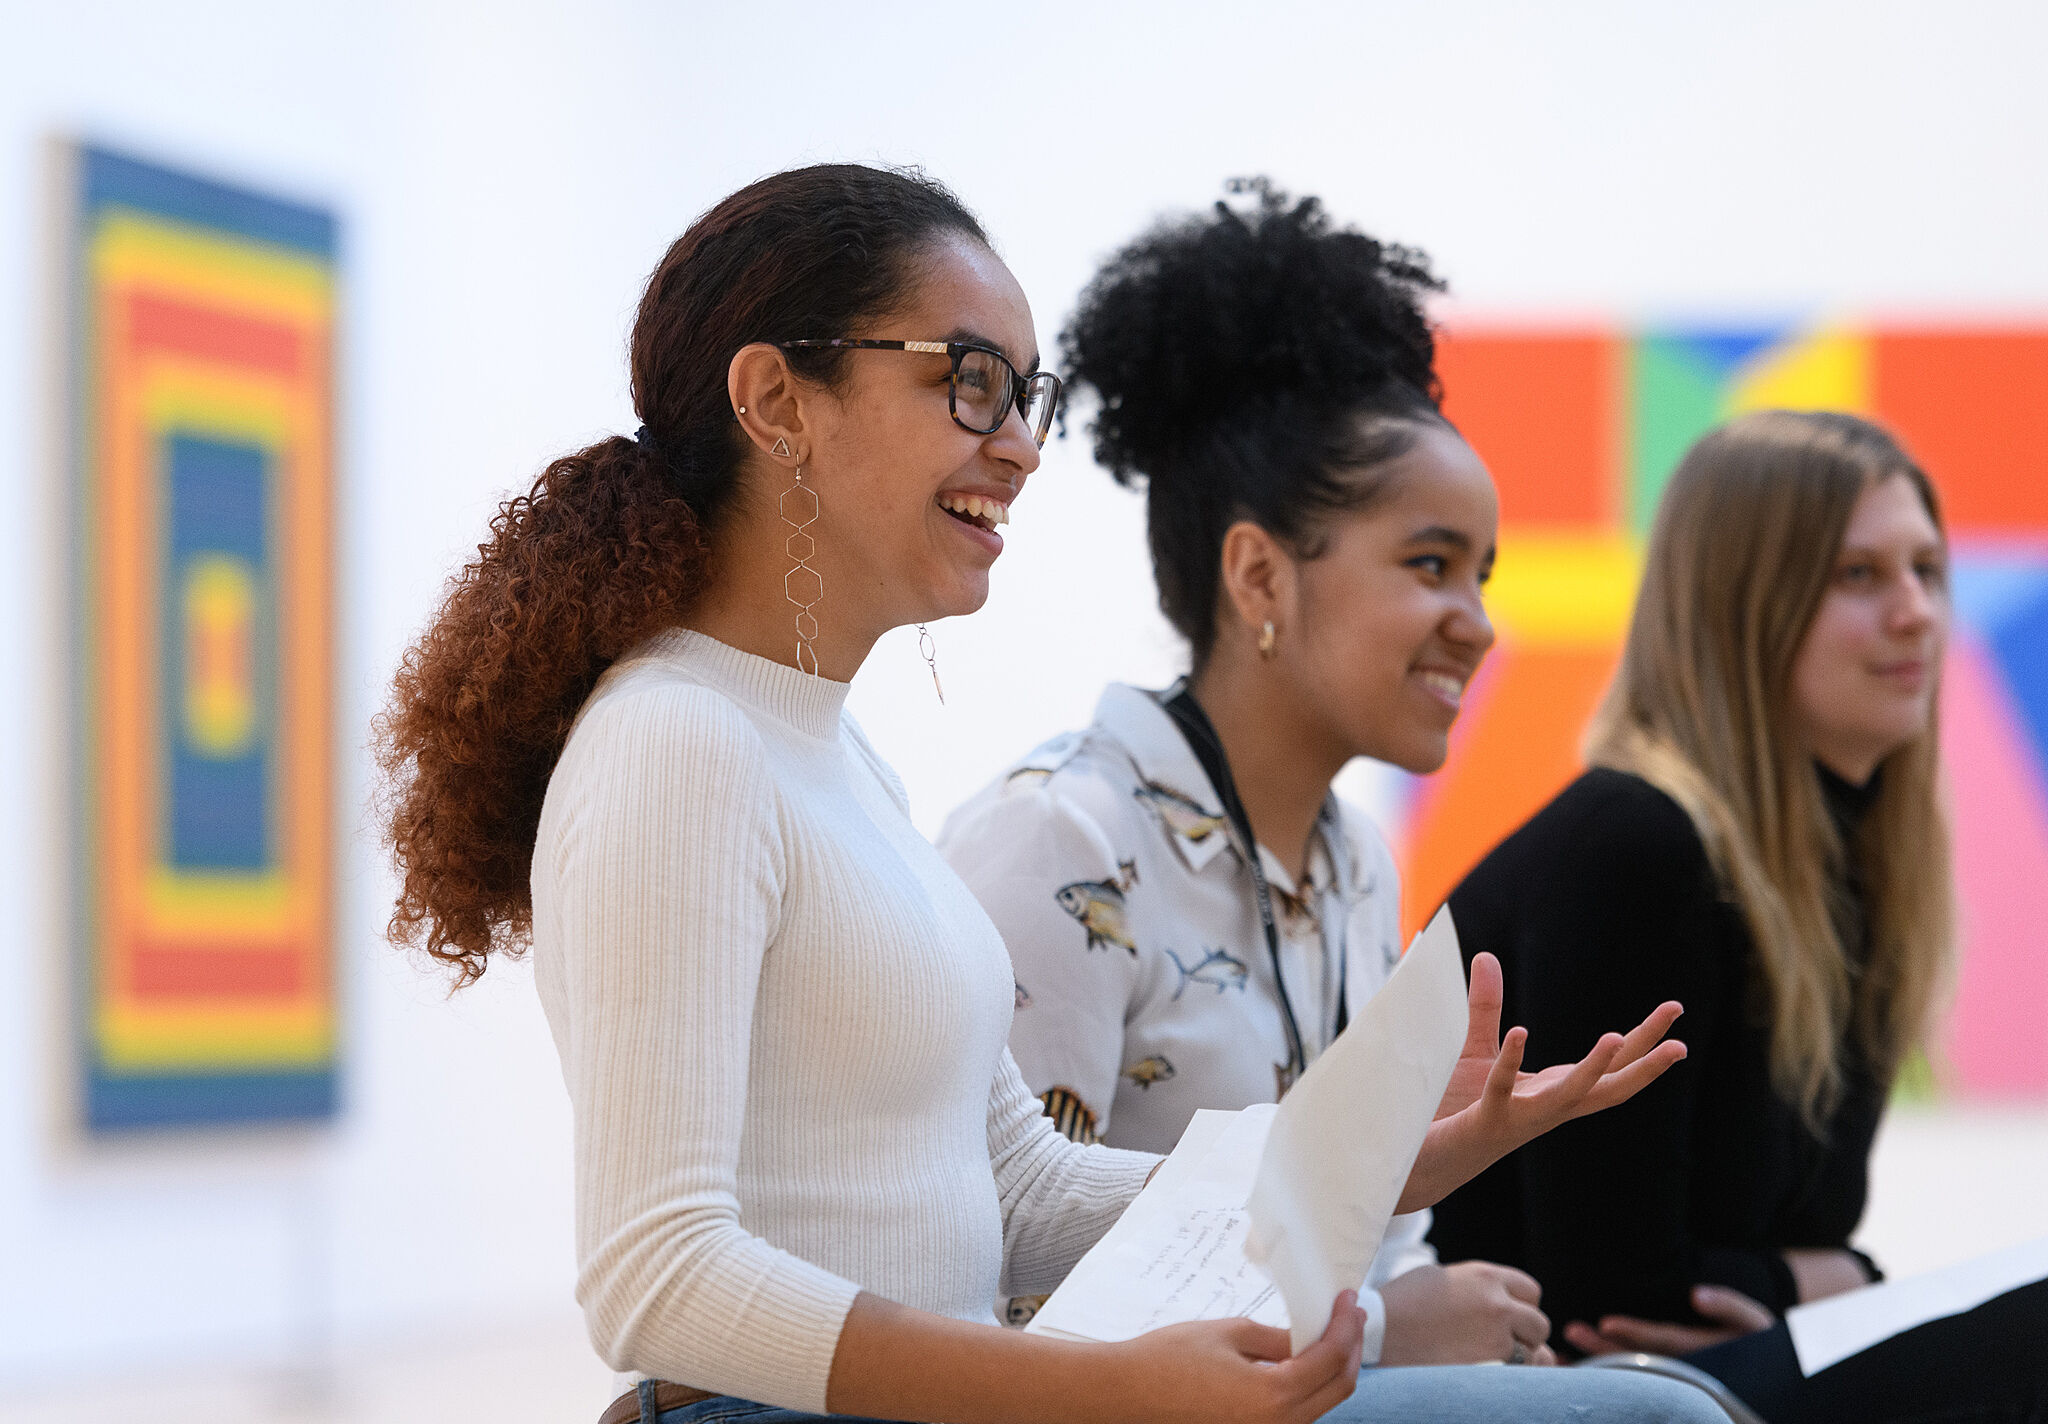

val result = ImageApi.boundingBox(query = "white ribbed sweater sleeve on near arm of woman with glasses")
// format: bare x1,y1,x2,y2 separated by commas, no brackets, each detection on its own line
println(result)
537,686,858,1414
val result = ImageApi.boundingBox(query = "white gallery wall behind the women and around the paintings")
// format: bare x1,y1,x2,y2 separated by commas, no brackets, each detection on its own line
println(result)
0,0,2048,1393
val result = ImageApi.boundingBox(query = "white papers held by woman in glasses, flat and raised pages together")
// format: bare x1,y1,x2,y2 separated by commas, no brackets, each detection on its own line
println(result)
1026,910,1464,1348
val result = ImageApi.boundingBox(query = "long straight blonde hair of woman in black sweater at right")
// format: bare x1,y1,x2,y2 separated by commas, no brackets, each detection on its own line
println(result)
1585,410,1954,1129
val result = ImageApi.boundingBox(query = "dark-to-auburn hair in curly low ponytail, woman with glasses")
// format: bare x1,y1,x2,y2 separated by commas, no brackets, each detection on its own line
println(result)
385,164,987,983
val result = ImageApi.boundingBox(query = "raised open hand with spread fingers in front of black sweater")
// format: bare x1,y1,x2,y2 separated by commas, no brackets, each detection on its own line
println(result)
1397,955,1686,1211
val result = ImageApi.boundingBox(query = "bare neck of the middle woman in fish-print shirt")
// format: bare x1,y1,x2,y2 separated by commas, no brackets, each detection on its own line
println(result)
1188,650,1350,883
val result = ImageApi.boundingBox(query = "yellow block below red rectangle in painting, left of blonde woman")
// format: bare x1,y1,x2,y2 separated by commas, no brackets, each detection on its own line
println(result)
1487,527,1642,647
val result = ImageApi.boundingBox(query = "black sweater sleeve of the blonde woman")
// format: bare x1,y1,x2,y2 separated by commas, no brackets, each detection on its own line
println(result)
1452,772,1790,1328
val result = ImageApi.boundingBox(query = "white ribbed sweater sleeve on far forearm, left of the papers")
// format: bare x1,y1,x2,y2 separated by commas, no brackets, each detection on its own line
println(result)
989,1051,1159,1295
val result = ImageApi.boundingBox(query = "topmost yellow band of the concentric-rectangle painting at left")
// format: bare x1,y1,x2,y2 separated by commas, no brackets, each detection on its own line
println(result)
92,207,334,326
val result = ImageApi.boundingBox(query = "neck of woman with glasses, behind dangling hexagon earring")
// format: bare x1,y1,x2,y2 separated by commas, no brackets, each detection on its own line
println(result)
690,497,887,682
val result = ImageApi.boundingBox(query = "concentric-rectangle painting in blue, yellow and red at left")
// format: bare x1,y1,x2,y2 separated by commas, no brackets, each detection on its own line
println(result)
70,148,338,1131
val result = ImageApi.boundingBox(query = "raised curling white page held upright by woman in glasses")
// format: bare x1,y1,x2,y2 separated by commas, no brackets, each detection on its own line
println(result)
1245,906,1466,1354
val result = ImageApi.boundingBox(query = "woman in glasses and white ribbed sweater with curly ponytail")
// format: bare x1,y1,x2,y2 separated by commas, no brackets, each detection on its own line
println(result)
379,166,1712,1424
